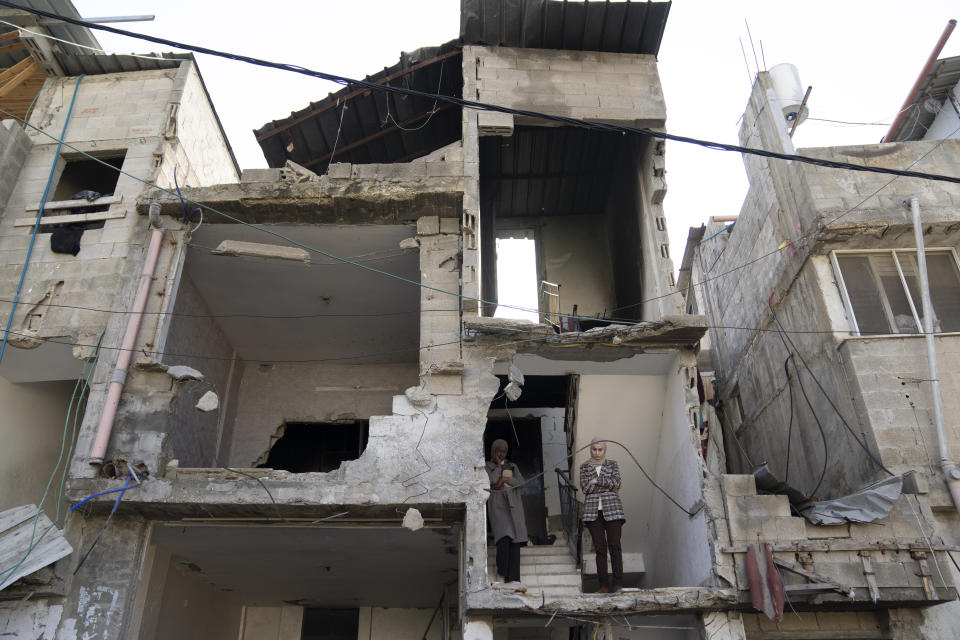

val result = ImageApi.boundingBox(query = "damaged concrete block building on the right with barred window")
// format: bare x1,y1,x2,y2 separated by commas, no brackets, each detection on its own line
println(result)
679,42,960,638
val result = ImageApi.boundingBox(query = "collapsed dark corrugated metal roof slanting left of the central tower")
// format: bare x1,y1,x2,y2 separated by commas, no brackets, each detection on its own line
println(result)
254,40,463,173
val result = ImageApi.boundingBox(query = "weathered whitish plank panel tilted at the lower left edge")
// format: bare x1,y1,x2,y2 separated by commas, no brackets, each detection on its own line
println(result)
0,504,73,590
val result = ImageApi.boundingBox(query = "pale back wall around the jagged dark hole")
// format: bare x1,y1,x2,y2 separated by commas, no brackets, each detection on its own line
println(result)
224,363,419,467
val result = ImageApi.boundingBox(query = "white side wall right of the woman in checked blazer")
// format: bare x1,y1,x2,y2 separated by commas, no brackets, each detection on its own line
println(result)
644,358,713,587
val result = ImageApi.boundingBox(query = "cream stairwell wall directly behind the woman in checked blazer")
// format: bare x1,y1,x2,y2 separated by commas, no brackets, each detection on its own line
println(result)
571,375,667,553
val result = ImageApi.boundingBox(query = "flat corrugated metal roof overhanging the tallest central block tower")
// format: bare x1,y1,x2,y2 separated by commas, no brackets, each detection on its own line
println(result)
460,0,670,55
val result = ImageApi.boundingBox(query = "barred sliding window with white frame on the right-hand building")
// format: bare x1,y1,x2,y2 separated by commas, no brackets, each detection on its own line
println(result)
831,249,960,335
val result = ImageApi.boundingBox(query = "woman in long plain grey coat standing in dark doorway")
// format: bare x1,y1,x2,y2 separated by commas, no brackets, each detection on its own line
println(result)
487,440,527,591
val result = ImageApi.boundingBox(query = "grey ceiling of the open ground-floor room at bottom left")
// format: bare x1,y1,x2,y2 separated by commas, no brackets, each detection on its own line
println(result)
152,523,459,608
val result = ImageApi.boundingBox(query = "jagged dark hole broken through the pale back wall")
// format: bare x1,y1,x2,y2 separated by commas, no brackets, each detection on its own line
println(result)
258,420,370,473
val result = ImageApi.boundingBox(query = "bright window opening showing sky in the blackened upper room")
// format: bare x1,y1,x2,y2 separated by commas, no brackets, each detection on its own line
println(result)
493,231,539,322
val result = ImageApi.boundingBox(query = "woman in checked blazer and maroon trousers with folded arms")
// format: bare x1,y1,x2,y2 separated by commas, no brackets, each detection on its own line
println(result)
580,438,626,593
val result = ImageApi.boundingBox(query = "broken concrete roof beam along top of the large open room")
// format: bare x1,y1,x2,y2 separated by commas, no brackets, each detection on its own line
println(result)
137,177,463,224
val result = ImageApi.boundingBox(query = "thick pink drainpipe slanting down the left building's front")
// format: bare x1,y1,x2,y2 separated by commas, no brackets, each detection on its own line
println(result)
90,228,163,464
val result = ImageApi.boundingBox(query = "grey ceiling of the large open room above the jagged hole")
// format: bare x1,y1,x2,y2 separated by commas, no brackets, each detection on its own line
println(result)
182,224,418,363
